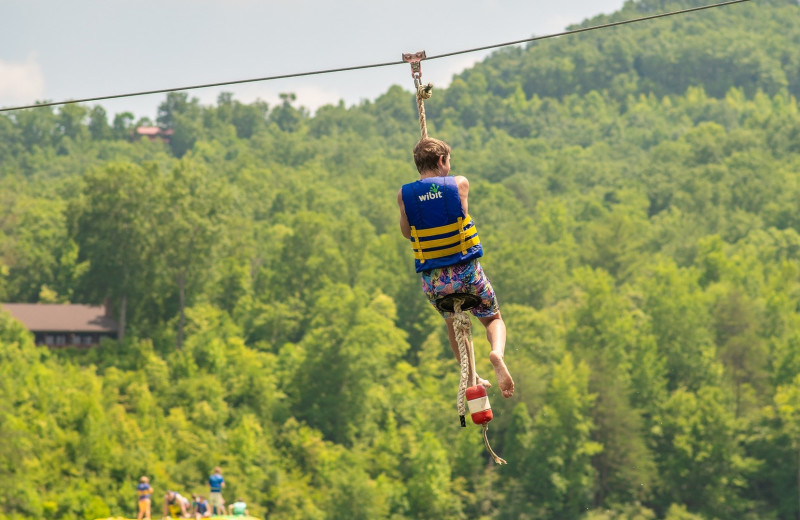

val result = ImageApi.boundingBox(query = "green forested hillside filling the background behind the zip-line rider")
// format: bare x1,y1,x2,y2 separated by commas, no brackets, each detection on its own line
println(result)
0,0,800,520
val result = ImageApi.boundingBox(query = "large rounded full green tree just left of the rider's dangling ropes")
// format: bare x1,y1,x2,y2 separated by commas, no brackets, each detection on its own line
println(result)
290,285,408,444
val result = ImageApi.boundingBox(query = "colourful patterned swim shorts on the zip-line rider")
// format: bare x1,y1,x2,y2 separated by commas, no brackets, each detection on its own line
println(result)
421,259,500,318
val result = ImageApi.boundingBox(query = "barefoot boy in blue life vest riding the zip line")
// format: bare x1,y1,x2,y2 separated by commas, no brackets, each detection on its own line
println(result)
397,137,514,398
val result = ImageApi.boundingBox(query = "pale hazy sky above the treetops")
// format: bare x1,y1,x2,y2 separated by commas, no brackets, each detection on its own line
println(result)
0,0,624,120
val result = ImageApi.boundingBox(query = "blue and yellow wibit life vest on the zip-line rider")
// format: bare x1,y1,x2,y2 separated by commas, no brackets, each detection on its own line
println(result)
402,176,483,273
